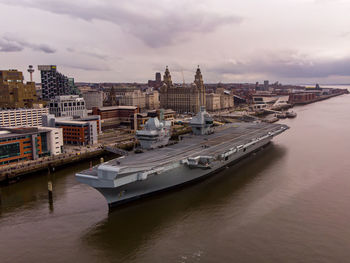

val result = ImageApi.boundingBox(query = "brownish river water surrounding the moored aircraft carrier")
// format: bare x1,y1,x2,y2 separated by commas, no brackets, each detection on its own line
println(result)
0,95,350,263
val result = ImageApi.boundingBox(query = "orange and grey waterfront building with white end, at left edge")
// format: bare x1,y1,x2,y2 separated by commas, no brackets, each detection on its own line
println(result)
0,127,63,165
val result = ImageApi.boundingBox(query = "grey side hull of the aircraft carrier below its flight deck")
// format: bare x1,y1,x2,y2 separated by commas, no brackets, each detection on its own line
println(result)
77,124,288,207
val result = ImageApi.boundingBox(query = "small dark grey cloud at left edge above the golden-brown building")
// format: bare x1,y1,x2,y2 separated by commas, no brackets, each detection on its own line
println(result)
0,36,55,54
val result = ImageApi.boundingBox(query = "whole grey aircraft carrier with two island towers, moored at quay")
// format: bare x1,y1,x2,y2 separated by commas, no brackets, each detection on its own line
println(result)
76,109,288,207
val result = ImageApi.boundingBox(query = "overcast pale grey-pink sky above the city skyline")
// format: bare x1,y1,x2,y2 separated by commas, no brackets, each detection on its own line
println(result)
0,0,350,84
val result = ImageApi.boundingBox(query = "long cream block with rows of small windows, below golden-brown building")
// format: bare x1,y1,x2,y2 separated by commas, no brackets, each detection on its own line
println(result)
0,108,49,128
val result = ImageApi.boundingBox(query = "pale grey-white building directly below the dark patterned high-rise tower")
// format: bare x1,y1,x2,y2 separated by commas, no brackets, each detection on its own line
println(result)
50,95,87,117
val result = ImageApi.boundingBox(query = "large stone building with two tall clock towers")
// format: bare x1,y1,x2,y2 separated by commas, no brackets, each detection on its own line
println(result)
160,67,205,113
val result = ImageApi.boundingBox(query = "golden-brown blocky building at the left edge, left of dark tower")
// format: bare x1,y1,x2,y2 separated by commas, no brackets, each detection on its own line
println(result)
0,69,38,109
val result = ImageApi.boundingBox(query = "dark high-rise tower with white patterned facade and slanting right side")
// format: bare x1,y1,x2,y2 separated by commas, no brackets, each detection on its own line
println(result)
38,65,71,100
